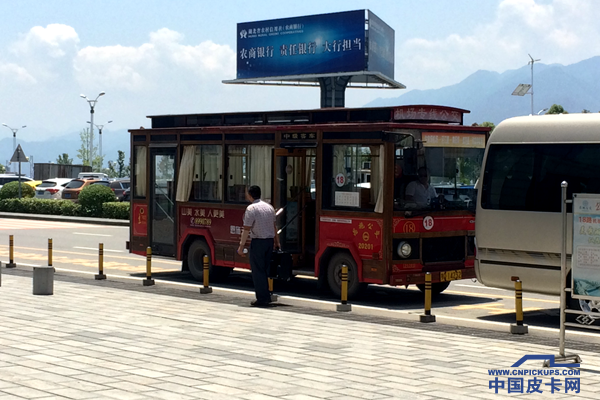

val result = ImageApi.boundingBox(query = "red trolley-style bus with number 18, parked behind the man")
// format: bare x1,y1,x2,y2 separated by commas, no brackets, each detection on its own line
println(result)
128,105,489,296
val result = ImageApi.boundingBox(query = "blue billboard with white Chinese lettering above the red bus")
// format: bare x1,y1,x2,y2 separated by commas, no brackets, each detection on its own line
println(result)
237,10,394,79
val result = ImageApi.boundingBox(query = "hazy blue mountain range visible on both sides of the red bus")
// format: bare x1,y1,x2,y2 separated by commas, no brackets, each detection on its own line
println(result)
0,56,600,171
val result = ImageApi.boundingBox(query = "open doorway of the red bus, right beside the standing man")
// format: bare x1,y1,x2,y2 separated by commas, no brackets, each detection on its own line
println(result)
273,149,316,260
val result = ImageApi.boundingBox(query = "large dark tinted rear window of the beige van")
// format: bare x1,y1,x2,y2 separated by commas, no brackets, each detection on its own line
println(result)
481,143,600,212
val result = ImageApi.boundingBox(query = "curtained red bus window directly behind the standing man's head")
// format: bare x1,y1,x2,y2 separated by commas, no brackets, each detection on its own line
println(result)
227,145,273,203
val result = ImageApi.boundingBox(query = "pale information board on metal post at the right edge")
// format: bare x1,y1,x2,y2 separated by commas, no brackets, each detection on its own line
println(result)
571,194,600,300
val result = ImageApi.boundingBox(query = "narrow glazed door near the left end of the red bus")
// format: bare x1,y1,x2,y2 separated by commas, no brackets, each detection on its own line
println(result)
149,147,177,257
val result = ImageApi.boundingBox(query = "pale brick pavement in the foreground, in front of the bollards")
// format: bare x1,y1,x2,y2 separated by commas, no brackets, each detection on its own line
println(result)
0,268,600,400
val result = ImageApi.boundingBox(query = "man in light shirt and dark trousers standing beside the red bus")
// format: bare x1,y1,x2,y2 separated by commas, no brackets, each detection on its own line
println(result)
237,185,280,307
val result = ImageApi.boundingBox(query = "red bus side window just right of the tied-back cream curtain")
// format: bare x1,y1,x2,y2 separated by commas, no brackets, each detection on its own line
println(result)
192,145,223,201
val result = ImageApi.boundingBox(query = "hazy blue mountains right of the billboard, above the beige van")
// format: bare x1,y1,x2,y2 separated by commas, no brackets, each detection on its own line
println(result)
366,56,600,125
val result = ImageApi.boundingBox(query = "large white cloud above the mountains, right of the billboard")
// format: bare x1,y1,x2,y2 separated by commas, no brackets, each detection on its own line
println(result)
397,0,600,89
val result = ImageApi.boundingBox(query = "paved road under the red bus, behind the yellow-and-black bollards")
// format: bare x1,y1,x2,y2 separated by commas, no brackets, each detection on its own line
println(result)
0,219,596,338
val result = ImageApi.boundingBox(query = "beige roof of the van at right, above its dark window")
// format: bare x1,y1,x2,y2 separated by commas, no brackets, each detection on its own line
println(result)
488,113,600,144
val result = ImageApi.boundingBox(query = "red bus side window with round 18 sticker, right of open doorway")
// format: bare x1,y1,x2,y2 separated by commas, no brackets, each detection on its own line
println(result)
323,144,383,212
